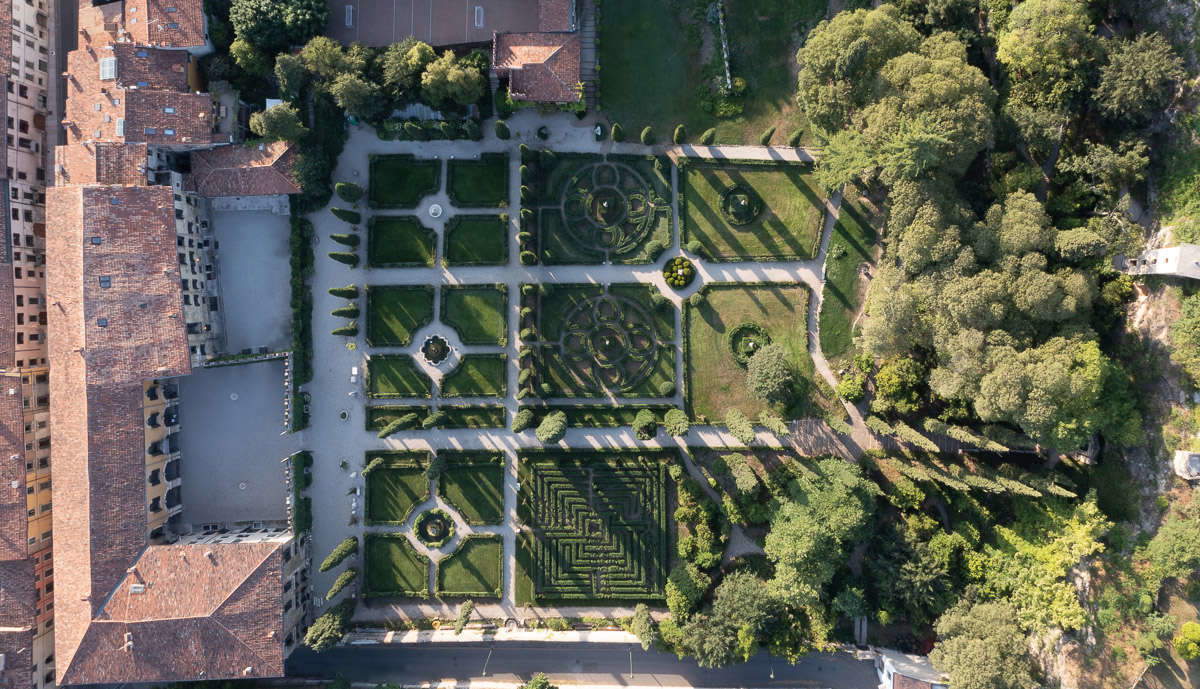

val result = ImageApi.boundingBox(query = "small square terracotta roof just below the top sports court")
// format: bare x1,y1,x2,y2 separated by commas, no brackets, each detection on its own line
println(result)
492,32,582,103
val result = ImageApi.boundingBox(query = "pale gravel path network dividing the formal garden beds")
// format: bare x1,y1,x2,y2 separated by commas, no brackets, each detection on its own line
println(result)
305,121,877,623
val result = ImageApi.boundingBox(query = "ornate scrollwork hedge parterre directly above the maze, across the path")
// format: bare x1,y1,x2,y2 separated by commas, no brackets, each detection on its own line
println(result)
522,284,676,397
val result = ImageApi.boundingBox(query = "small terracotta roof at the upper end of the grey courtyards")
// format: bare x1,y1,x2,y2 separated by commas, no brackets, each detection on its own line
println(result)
186,142,300,197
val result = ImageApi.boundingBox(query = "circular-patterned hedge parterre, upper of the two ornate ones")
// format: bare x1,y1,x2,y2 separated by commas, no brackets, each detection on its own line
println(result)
523,152,671,264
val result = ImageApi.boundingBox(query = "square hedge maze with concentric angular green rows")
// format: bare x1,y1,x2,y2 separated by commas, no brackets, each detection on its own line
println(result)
517,451,677,600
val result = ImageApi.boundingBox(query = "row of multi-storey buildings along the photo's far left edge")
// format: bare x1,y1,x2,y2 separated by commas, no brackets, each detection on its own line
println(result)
0,0,54,689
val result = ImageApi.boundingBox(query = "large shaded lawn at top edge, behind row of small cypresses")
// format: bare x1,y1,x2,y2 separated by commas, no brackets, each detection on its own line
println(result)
599,0,827,144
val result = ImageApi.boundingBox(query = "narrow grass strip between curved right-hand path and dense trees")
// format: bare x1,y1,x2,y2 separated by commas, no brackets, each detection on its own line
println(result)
821,194,878,361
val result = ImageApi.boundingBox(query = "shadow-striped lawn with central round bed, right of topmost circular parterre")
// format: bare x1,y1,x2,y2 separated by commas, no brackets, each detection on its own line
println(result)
680,162,824,260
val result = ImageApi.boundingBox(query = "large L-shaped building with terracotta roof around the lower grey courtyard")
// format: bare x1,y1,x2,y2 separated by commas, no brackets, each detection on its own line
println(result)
48,184,308,684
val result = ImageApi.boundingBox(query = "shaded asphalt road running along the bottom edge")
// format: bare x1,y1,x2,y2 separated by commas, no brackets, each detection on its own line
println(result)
287,642,877,689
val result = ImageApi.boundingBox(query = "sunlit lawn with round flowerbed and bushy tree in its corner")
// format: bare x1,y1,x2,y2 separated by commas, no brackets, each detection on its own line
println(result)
685,284,820,423
